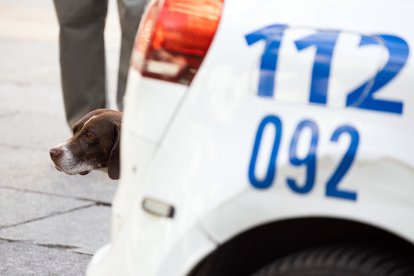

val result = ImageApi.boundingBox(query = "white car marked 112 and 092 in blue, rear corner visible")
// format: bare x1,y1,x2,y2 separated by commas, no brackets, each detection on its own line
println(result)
87,0,414,276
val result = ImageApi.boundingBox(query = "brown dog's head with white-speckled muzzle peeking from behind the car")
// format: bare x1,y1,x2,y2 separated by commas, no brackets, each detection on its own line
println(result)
49,109,122,179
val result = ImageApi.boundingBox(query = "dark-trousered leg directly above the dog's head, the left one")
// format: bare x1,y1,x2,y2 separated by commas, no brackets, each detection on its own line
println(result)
54,0,108,126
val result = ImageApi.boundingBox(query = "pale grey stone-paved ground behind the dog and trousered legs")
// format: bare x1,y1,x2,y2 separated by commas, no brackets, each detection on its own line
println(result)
0,0,119,276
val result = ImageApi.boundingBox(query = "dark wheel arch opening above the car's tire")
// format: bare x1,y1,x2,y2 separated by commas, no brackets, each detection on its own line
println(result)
189,217,414,276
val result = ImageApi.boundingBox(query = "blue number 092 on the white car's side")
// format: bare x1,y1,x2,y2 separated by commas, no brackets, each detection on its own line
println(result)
249,115,359,201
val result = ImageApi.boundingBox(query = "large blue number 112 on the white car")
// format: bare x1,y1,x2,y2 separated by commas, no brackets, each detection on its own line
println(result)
245,24,410,114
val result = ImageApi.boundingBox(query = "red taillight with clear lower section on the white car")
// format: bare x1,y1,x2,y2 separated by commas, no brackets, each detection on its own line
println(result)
131,0,223,84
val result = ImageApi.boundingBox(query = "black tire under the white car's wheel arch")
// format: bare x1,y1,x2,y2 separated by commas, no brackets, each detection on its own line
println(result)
253,246,414,276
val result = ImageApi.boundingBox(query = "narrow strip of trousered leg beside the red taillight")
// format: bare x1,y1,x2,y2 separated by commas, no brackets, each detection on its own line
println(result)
117,0,147,110
